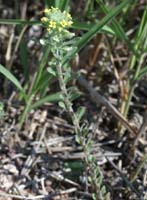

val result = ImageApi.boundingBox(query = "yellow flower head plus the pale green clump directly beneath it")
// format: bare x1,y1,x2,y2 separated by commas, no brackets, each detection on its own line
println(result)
41,7,74,48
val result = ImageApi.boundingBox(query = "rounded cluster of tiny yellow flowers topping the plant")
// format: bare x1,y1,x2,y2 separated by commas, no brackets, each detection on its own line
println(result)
41,7,73,32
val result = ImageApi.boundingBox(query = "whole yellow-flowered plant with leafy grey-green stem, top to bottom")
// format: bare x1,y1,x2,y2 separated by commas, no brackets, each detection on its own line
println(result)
41,7,106,199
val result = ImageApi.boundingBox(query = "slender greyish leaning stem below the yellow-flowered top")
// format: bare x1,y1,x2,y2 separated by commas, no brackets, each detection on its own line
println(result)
56,61,106,200
